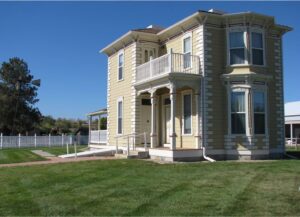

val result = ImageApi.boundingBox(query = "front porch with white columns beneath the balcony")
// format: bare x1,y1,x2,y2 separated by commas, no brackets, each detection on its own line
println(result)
136,79,202,152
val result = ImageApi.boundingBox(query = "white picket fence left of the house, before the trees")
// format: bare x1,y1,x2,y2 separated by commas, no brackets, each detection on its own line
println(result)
0,134,88,149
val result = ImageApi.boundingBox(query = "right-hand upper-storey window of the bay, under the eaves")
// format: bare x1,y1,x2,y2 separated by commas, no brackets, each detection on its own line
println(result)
251,32,264,65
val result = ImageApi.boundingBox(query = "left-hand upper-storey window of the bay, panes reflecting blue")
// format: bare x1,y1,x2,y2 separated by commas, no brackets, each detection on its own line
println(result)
229,31,246,65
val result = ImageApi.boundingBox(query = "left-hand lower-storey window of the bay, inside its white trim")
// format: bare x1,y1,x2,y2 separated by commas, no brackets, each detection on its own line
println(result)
231,91,246,134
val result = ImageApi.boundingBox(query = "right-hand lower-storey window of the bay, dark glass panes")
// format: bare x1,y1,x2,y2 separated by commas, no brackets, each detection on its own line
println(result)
253,91,266,134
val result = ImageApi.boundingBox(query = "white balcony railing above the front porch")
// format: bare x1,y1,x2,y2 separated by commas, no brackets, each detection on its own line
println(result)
136,53,200,82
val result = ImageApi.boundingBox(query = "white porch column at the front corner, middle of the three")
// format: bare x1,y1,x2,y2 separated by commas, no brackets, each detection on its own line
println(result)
170,85,176,150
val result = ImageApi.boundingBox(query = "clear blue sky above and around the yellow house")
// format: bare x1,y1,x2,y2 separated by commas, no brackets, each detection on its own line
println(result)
0,2,300,118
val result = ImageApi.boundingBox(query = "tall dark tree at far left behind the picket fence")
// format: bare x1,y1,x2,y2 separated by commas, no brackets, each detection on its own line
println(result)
0,57,41,134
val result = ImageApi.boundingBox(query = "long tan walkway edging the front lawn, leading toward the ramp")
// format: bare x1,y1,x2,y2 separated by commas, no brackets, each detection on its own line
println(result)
0,156,116,168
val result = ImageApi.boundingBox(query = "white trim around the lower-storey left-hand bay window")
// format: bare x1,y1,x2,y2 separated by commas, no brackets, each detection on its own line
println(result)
227,85,250,136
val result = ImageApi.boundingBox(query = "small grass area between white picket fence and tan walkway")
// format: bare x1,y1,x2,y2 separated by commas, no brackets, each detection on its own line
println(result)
0,145,87,164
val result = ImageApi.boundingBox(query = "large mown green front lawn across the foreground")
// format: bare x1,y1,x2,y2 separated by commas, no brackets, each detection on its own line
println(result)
0,160,300,216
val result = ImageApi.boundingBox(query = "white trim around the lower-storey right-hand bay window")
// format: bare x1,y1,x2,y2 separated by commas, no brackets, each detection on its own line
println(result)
251,86,269,136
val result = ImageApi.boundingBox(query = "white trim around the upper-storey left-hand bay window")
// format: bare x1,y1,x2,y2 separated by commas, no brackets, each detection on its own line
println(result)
226,27,249,67
